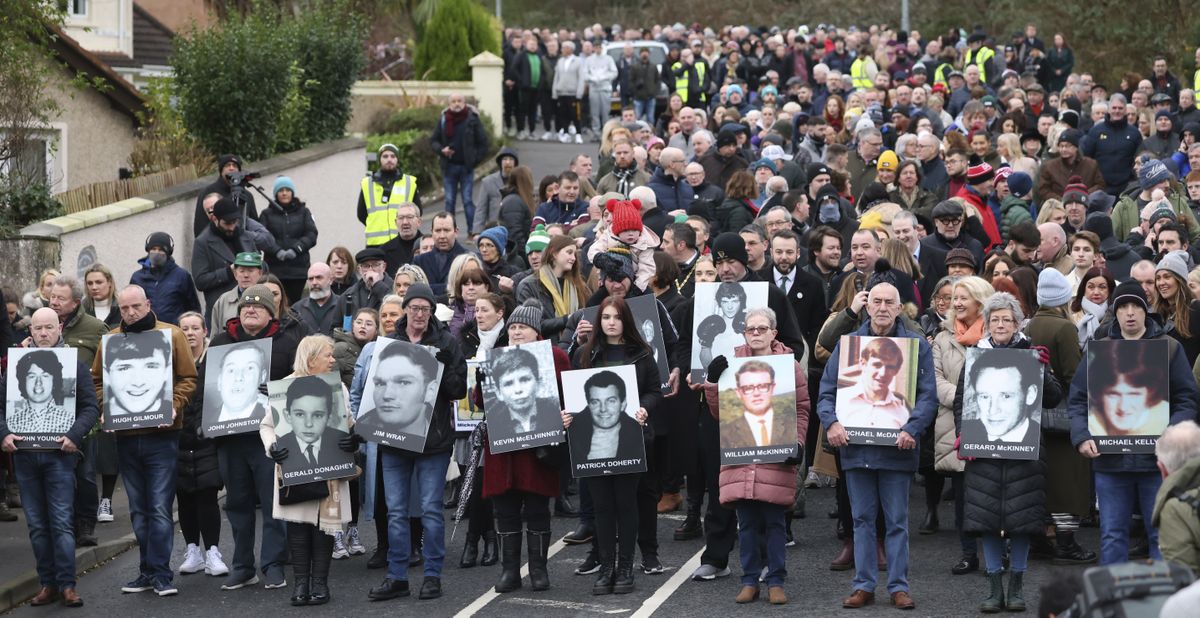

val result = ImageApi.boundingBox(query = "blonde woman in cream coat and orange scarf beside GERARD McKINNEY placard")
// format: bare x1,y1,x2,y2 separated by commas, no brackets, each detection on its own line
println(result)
920,276,995,575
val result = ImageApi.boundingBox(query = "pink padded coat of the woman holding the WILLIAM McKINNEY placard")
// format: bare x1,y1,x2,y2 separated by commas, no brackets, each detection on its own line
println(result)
704,341,811,506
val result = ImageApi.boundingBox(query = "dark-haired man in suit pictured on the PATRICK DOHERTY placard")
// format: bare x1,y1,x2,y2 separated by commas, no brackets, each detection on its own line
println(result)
568,371,642,463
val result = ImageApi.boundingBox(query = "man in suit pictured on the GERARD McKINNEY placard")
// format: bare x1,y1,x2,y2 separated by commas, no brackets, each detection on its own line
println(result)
961,354,1042,446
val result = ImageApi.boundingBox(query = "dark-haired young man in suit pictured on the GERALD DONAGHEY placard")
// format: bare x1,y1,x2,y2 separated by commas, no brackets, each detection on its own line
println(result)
276,376,349,472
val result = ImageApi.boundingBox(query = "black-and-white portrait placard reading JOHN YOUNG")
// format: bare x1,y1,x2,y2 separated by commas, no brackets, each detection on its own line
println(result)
5,348,78,450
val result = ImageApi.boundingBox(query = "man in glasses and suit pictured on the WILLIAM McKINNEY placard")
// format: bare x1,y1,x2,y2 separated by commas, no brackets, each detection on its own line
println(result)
720,360,797,449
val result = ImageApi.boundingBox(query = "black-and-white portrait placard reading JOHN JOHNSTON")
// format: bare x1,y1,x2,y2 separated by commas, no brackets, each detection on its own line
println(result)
203,338,271,438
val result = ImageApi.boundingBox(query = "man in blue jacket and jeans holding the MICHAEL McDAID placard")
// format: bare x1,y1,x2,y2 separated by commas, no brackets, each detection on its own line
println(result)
817,283,937,610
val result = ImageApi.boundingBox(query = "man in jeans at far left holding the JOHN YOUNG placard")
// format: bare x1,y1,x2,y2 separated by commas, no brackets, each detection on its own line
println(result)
0,307,100,607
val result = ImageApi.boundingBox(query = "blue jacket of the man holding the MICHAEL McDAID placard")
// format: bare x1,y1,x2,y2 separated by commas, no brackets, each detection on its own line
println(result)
817,319,937,473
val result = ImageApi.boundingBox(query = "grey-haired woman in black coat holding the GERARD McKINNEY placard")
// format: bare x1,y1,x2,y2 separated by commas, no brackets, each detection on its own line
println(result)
954,292,1062,613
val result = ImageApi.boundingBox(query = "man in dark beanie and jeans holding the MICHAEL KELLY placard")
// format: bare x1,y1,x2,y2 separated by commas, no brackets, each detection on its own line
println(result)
1068,281,1198,564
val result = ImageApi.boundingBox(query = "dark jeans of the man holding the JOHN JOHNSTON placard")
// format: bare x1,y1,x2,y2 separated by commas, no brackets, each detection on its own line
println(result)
217,433,288,575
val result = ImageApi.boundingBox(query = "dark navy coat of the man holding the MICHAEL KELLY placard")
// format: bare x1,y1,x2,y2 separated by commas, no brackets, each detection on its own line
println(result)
1067,317,1200,474
